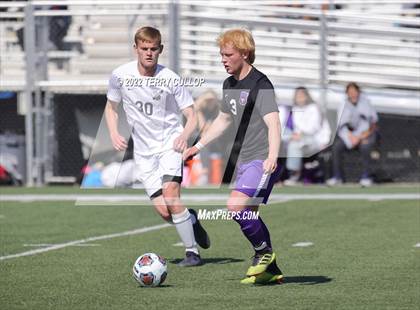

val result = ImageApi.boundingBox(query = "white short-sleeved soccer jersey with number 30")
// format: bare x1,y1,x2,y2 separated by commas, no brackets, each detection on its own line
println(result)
107,61,194,156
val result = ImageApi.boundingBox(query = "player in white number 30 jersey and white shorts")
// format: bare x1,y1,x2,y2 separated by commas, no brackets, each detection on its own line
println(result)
105,27,210,266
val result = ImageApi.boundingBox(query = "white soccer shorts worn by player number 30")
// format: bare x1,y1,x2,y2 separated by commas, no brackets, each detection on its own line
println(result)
134,149,183,198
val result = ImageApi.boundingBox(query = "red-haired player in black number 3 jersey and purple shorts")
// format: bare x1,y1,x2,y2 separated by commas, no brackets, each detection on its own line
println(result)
184,29,283,284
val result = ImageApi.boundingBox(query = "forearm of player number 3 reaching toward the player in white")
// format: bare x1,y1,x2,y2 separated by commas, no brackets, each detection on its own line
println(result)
183,111,232,160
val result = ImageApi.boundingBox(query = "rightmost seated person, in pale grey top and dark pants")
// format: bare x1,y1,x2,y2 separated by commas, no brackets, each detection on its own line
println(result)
327,83,378,186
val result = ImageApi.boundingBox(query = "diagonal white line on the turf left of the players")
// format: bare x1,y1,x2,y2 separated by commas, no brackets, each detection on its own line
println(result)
0,223,172,261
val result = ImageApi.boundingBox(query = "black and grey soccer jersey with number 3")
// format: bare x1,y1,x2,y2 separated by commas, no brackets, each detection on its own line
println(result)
221,67,278,163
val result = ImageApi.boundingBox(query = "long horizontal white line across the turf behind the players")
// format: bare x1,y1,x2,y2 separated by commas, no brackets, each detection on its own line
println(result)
0,193,420,205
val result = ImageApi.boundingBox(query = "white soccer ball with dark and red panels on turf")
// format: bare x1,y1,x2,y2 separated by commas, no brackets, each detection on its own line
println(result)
133,253,168,286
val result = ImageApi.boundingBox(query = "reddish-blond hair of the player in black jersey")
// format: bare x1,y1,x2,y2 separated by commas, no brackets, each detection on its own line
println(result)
217,29,255,64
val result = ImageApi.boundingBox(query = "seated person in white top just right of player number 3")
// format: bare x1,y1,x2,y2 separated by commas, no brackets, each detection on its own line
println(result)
283,87,331,185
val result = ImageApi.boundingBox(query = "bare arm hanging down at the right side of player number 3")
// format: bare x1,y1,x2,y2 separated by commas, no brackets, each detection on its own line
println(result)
263,112,281,173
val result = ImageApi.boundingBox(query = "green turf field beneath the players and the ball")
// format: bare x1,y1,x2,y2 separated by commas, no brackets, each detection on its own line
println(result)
0,185,420,310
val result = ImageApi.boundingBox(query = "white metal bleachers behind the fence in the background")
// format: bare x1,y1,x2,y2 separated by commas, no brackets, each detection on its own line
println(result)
0,1,420,91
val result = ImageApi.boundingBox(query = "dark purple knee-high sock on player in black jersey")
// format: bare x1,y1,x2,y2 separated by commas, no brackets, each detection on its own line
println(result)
234,209,271,253
